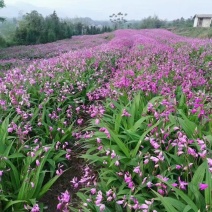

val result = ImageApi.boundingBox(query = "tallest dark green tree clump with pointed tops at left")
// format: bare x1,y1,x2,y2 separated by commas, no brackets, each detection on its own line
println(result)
14,11,73,45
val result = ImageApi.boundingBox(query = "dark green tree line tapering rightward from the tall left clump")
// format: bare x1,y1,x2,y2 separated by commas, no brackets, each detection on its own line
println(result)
14,11,111,45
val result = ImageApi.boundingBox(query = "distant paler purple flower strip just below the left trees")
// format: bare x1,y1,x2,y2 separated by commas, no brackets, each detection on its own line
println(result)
0,33,113,71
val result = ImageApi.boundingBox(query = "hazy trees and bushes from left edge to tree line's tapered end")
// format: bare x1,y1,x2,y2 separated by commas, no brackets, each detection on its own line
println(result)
0,11,111,47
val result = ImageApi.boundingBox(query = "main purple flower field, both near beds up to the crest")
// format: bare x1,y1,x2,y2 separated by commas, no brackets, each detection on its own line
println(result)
0,30,212,212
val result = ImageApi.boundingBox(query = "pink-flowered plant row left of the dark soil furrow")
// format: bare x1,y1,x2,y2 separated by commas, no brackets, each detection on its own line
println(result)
0,35,121,212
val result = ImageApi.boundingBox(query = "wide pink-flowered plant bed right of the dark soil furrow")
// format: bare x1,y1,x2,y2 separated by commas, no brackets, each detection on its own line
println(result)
68,31,212,212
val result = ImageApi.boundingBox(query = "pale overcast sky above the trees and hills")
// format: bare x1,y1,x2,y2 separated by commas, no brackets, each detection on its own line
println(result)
0,0,212,20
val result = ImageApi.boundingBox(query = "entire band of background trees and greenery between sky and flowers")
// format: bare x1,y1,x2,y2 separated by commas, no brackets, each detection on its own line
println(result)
0,4,212,47
